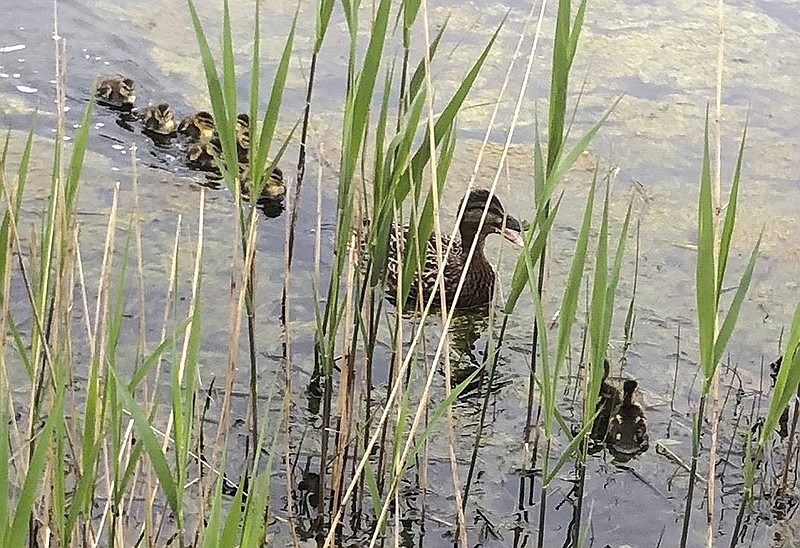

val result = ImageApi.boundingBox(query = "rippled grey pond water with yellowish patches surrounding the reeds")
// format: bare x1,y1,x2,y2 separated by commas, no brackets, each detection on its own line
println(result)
0,0,800,547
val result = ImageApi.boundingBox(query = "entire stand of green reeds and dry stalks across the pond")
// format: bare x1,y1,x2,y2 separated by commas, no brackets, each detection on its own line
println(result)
0,0,800,547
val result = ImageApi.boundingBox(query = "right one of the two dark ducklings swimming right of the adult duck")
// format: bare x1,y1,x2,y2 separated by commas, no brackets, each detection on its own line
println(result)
606,379,650,460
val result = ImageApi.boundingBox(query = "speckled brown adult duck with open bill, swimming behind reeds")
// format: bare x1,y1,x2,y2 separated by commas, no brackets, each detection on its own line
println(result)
386,189,522,309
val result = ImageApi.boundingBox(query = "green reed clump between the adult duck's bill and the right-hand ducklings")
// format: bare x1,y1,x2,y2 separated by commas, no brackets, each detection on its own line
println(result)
494,0,630,547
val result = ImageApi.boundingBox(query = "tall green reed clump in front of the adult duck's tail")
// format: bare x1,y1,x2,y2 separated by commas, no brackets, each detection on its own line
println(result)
318,2,506,543
